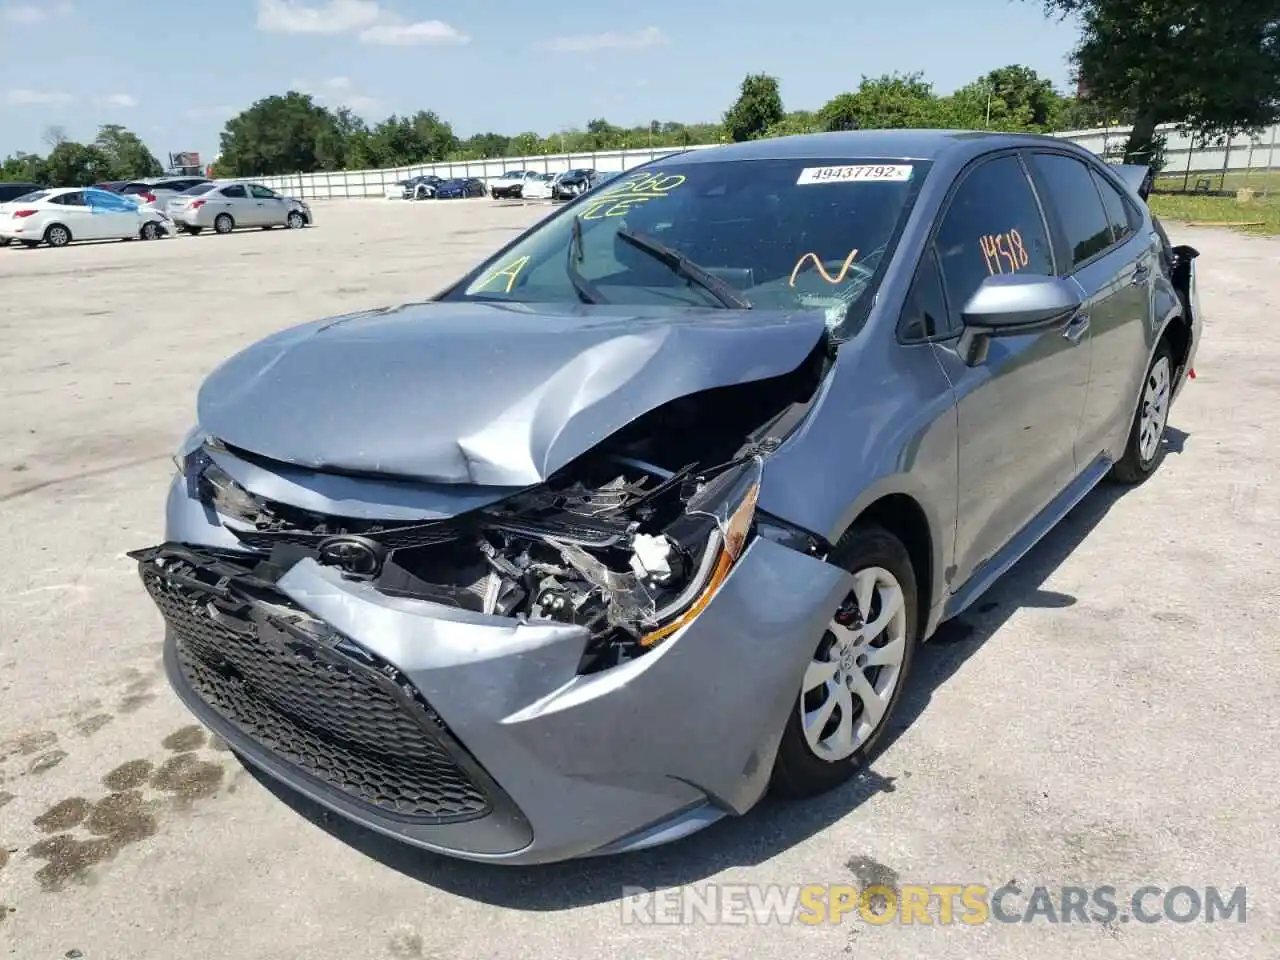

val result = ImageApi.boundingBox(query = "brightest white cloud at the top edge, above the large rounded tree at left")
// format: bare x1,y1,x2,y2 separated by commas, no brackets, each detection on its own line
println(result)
257,0,471,46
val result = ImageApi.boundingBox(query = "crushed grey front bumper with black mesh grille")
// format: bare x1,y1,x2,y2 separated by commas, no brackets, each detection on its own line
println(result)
134,480,851,863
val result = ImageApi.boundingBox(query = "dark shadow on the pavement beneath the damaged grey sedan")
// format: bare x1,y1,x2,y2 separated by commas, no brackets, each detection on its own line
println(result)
248,429,1188,911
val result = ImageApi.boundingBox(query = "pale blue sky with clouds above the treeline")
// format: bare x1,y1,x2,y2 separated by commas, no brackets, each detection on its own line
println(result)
0,0,1076,160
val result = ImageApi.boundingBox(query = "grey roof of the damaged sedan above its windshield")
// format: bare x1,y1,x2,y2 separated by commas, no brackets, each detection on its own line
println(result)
662,129,1070,164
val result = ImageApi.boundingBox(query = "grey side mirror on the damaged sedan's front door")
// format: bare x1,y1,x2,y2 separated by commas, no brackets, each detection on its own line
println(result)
957,274,1084,366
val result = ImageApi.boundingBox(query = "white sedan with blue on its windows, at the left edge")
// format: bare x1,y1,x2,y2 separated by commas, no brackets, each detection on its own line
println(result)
0,187,173,247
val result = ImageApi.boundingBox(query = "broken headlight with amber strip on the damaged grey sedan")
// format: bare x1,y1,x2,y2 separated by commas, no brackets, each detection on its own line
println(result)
640,457,763,648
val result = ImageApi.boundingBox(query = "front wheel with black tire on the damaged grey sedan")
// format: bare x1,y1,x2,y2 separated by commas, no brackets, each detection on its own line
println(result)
771,525,919,799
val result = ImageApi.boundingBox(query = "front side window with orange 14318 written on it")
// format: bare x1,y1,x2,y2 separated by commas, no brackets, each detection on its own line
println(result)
934,155,1055,329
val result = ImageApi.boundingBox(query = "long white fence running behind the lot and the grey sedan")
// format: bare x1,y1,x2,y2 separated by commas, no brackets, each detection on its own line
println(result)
252,125,1280,200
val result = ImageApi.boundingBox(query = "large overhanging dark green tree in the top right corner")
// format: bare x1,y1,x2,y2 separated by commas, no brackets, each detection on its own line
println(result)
1042,0,1280,163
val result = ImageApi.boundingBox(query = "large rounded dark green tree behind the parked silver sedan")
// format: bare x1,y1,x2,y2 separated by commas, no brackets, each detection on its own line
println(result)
218,90,335,177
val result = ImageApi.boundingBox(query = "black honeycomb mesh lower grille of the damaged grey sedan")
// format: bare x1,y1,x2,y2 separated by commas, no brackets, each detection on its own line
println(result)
141,552,492,823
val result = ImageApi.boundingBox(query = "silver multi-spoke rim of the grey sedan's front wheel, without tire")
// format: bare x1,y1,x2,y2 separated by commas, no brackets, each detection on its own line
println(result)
799,567,908,763
